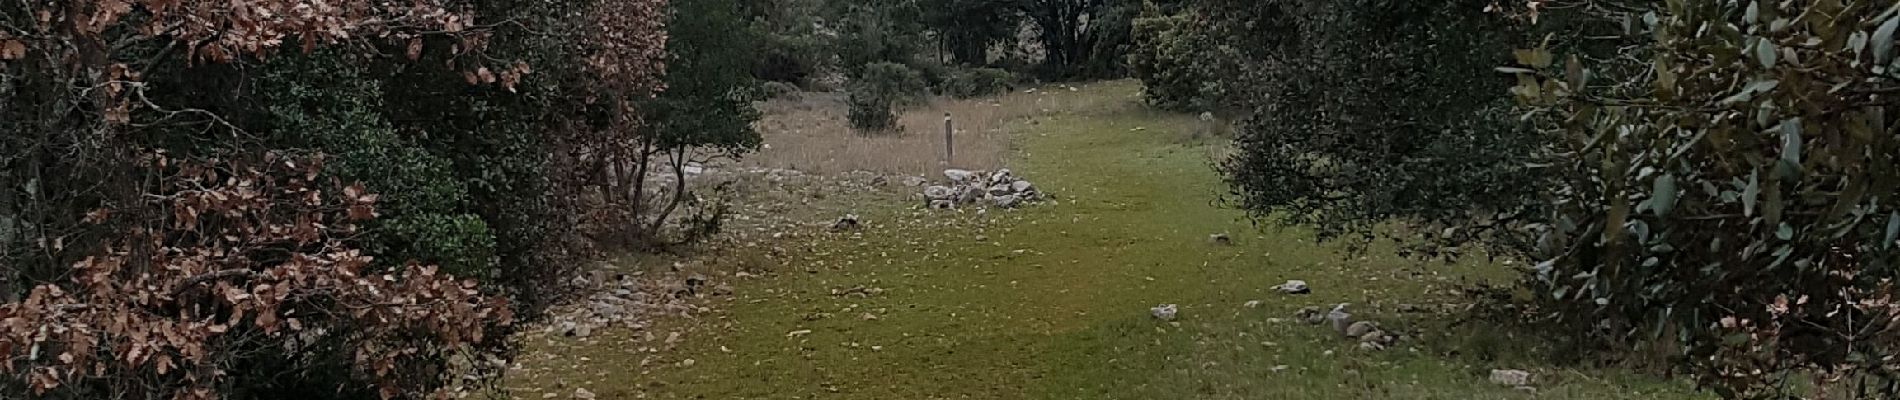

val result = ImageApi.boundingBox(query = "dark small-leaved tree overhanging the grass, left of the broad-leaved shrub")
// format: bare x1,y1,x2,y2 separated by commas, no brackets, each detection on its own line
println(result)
1216,0,1549,254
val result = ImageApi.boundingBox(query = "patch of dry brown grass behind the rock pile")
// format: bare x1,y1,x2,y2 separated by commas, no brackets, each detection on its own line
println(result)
743,83,1115,176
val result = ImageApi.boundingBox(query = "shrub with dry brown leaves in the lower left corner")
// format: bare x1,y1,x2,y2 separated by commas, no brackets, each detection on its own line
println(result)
0,154,511,400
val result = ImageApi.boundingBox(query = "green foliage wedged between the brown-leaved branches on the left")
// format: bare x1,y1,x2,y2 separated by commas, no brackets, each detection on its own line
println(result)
255,51,496,277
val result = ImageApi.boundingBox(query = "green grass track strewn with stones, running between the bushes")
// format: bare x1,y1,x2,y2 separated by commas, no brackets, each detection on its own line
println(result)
511,82,1699,398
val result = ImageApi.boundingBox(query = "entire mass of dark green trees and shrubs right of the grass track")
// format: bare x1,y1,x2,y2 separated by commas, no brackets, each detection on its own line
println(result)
1170,0,1900,398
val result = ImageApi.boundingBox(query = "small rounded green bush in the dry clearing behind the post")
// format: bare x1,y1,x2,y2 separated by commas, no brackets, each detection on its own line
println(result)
846,63,927,133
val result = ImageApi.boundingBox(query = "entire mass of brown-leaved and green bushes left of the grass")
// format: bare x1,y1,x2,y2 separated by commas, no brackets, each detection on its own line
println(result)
0,0,680,398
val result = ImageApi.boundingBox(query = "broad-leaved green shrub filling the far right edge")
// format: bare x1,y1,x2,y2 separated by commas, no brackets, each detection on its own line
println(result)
1499,0,1900,398
